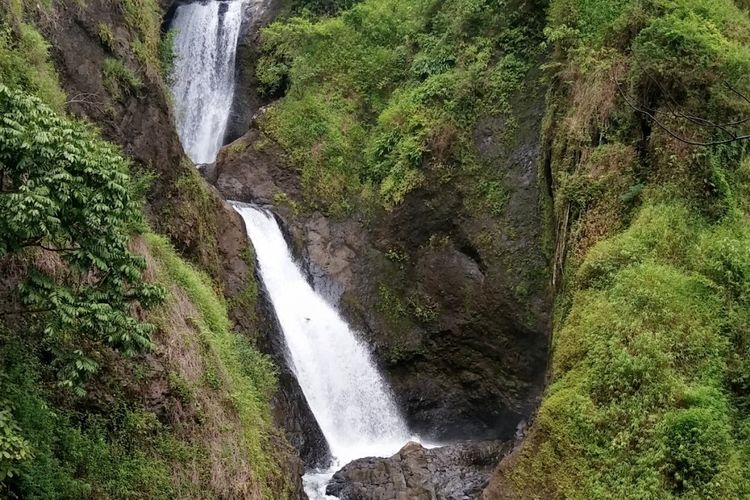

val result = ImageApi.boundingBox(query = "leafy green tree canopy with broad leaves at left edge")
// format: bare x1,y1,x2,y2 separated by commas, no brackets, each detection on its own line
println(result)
0,86,164,389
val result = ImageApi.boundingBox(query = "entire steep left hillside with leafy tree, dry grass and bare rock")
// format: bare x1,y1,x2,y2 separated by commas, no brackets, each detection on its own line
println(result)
0,0,301,499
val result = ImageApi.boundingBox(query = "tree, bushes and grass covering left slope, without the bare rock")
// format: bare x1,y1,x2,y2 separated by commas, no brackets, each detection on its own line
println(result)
0,8,288,499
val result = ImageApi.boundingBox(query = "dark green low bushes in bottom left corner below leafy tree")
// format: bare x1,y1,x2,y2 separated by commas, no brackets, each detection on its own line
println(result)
0,338,172,499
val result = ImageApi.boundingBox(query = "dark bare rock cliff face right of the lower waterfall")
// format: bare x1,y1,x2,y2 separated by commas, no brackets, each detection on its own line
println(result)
215,0,550,446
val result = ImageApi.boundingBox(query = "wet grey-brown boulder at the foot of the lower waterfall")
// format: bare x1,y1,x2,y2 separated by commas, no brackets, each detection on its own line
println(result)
326,441,509,500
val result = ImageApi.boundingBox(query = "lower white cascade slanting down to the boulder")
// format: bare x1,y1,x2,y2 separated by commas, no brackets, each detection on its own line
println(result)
234,203,410,500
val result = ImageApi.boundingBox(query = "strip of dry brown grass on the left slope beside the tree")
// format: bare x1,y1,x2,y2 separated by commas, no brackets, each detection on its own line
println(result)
131,238,263,500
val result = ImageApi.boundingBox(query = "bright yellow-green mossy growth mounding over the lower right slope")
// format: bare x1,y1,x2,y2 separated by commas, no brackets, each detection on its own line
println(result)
515,204,750,498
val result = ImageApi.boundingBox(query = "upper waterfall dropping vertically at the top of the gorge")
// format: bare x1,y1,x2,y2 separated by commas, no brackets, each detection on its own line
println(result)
171,0,243,164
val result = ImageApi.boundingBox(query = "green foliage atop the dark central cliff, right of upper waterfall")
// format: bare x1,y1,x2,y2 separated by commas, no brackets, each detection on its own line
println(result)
258,0,541,213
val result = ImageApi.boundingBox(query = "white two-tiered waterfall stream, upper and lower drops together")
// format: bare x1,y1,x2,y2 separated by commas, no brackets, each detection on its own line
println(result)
172,0,418,500
